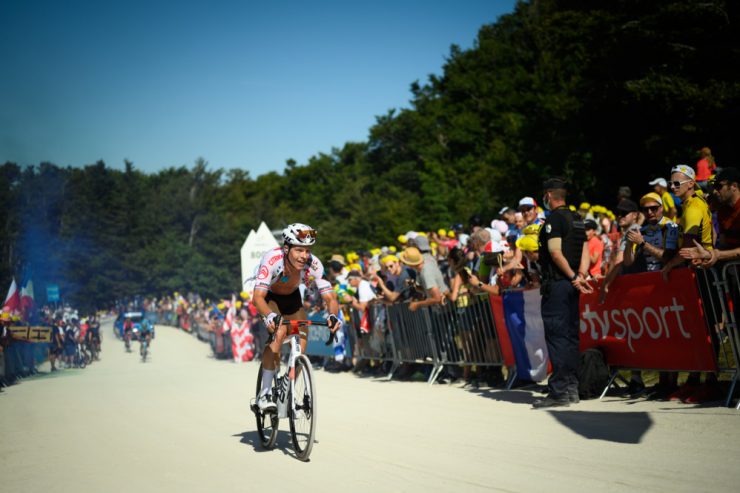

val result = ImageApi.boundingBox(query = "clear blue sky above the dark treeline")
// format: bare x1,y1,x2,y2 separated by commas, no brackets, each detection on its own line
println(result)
0,0,515,176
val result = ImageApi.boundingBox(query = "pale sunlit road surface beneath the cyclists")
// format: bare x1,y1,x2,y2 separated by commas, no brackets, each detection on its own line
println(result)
0,325,740,493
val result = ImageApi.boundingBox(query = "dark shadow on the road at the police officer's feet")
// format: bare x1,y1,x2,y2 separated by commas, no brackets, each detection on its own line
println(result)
548,411,653,444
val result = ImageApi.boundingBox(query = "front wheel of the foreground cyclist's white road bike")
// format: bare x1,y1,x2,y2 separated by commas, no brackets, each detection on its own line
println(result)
288,354,316,461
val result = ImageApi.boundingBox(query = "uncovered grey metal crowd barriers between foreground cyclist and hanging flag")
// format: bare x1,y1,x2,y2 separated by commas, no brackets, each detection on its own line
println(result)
350,294,504,384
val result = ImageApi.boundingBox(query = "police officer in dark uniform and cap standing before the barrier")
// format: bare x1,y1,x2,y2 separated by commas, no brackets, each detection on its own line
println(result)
533,178,593,409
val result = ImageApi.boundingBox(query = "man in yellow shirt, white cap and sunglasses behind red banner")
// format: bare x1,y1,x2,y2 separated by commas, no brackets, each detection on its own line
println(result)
663,164,714,281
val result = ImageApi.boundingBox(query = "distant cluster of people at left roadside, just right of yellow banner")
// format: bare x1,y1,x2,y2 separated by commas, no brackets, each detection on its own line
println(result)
49,315,101,371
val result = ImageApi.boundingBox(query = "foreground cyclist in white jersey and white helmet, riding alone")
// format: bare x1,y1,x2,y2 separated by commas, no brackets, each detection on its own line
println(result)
253,223,342,411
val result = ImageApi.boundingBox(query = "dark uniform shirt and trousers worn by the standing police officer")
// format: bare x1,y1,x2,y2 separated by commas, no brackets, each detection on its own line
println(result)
539,206,586,402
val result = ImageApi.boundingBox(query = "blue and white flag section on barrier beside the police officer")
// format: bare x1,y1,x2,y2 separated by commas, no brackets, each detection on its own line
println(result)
504,290,548,382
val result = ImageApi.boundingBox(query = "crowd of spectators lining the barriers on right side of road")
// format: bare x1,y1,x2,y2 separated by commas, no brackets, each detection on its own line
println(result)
114,148,740,402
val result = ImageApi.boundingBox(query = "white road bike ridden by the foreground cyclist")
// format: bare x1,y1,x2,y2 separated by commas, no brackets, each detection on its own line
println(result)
251,320,334,461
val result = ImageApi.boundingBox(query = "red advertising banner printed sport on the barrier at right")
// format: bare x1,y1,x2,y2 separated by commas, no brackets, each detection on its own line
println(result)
580,269,717,371
